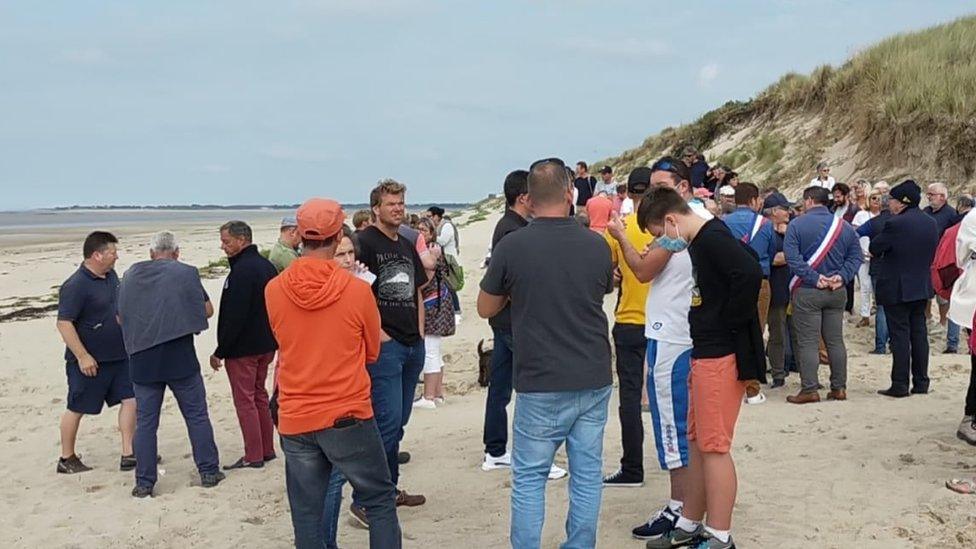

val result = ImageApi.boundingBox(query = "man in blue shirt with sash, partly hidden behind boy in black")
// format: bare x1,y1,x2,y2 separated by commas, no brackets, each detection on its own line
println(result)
723,183,776,404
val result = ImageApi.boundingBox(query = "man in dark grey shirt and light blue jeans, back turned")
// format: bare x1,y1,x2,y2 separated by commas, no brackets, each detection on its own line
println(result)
478,159,613,547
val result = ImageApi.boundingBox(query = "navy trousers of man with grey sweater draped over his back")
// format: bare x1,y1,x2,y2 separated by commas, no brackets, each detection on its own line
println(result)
132,372,219,488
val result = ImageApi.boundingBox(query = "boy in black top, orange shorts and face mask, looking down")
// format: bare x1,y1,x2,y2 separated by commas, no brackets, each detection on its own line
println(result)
637,188,765,549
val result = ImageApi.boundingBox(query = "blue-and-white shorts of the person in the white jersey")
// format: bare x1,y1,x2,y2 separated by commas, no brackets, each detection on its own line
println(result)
647,339,691,471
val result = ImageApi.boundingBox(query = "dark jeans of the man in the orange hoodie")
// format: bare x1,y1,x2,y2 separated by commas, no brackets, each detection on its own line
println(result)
281,419,401,549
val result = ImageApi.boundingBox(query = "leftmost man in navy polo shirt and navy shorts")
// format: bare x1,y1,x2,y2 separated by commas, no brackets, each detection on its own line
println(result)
57,231,136,474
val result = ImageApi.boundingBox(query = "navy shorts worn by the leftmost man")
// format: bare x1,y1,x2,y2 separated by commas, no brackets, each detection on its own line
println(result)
65,360,135,415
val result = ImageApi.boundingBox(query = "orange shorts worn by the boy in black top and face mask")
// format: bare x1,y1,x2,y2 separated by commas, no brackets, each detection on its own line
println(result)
688,355,746,454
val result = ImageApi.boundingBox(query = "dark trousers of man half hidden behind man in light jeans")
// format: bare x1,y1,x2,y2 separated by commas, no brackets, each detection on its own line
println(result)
484,328,513,457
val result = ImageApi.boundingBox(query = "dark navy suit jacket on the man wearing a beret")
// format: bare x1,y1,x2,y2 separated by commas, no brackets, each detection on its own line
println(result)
868,208,939,305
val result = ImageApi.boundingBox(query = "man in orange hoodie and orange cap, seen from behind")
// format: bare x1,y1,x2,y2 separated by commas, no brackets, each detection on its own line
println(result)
265,198,401,548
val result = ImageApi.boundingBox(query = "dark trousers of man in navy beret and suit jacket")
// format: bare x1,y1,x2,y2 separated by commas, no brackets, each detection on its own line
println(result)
884,299,929,391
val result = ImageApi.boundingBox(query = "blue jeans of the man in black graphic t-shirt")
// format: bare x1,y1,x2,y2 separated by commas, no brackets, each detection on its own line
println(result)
353,339,425,490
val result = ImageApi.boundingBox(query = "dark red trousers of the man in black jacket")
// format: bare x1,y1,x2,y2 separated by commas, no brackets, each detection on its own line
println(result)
224,352,275,463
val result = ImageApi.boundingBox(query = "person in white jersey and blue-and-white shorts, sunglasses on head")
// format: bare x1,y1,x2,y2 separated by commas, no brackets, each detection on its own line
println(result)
607,157,713,547
